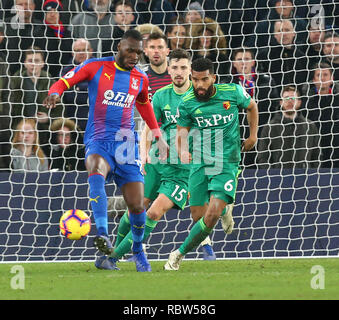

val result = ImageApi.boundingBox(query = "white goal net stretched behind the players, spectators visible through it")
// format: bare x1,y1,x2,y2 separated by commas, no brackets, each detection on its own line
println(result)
0,0,339,262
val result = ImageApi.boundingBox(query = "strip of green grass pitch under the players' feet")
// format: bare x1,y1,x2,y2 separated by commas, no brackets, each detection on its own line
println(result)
0,258,339,301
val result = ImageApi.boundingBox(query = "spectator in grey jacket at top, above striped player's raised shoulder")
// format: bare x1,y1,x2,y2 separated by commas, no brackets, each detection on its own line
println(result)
69,0,115,57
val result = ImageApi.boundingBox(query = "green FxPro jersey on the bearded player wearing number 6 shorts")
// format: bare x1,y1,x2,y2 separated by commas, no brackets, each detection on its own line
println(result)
177,83,251,165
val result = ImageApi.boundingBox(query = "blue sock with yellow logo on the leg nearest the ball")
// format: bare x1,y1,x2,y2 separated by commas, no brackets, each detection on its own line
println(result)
88,174,108,236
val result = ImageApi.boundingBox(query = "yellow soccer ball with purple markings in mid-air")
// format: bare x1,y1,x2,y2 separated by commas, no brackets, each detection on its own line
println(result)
59,209,91,240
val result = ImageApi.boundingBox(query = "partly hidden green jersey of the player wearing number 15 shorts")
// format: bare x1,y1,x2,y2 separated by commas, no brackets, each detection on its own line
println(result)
150,84,192,170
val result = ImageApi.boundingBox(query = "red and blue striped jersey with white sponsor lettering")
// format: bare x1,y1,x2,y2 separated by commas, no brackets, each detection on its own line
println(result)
60,57,148,143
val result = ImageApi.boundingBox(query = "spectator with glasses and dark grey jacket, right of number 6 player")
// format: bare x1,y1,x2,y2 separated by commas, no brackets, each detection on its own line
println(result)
258,86,321,168
